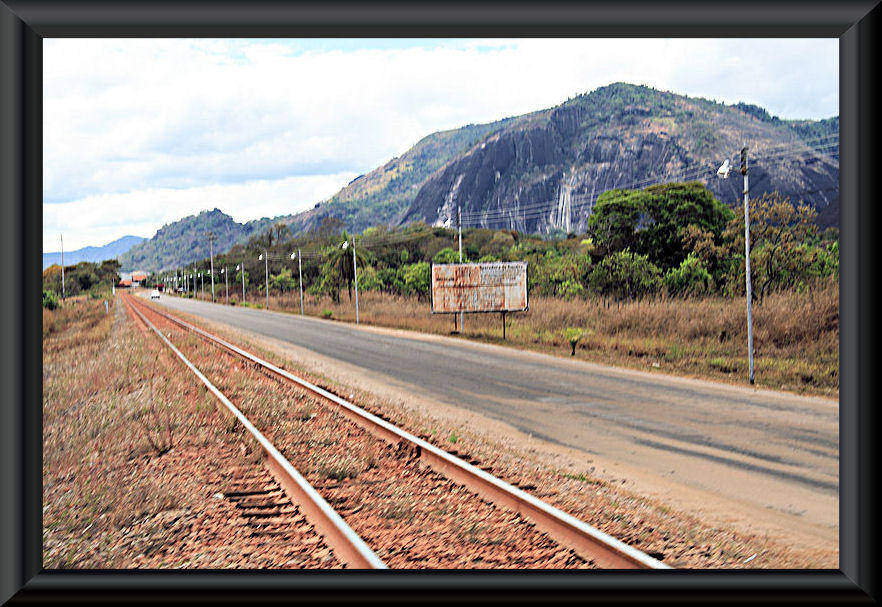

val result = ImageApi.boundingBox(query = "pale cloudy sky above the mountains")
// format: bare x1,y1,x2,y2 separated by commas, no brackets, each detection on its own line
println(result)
43,39,839,251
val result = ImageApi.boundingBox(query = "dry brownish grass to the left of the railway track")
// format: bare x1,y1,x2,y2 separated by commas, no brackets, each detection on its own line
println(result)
43,297,227,569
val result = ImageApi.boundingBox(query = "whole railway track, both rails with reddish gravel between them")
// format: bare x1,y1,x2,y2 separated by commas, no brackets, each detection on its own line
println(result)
118,295,669,569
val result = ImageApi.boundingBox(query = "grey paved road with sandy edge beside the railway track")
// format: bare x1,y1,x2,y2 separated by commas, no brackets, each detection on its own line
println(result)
148,297,839,548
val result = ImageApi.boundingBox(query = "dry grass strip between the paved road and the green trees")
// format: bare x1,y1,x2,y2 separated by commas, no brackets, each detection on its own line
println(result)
249,282,839,397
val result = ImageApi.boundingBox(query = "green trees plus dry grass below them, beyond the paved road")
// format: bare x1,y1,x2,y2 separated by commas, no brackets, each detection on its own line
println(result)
167,183,839,396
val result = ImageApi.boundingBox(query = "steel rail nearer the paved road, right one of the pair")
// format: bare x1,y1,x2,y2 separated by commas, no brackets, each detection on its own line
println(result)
127,294,672,569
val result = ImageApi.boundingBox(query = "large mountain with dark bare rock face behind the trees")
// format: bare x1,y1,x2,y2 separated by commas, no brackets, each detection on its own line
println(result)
397,84,839,233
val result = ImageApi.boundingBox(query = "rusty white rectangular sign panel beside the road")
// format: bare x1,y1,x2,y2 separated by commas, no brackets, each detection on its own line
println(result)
432,261,527,314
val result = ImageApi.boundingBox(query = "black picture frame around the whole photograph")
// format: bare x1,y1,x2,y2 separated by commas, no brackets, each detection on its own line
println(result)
0,0,882,603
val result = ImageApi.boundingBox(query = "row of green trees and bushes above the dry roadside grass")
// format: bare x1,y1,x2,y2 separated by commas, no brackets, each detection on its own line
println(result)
152,182,839,301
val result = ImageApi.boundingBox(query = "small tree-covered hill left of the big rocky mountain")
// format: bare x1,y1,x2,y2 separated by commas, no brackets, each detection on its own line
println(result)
120,209,276,271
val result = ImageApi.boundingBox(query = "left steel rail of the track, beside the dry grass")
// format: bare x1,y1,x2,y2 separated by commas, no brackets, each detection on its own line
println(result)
125,295,388,569
